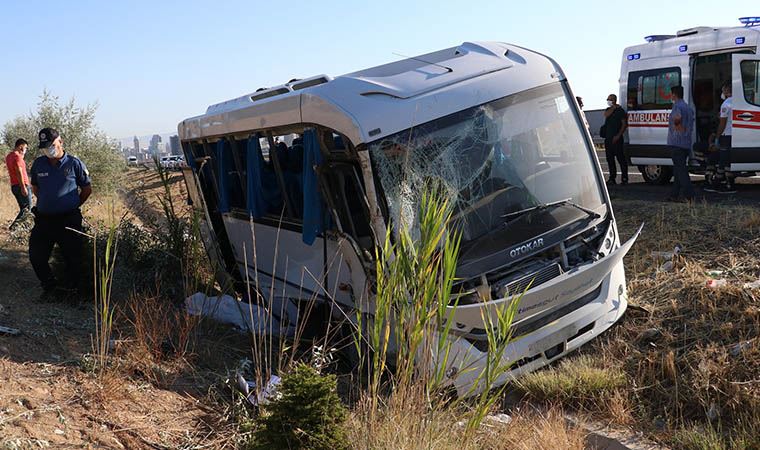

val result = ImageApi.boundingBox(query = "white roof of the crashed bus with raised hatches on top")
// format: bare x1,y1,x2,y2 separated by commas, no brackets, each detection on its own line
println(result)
178,42,564,145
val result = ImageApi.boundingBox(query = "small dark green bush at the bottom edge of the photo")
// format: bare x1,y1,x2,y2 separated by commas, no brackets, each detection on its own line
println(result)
254,364,349,450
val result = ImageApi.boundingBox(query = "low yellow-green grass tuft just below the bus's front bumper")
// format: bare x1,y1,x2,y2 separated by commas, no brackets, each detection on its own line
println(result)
517,355,626,404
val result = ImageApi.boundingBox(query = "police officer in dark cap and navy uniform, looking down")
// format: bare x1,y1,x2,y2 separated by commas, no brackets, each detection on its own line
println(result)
29,128,92,295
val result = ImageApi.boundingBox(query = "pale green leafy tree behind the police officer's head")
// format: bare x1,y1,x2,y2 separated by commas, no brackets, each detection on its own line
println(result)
0,90,125,193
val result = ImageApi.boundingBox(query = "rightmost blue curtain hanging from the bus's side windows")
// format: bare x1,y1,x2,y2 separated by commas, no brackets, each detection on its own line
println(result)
302,128,324,245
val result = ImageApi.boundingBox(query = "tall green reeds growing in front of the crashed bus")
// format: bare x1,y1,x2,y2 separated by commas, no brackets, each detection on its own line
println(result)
355,187,521,430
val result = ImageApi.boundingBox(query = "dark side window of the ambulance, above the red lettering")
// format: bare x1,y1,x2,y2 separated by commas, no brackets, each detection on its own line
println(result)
627,67,681,111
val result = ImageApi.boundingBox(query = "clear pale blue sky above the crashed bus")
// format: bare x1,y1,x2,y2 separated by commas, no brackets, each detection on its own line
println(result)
0,0,760,138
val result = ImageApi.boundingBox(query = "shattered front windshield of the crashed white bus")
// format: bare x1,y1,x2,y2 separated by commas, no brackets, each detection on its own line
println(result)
369,83,603,242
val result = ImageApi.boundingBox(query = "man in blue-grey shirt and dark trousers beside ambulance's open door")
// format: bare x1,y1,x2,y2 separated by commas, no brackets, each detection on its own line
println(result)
667,86,694,202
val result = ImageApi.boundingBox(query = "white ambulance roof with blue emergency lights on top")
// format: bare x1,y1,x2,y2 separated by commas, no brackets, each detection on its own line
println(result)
623,26,760,62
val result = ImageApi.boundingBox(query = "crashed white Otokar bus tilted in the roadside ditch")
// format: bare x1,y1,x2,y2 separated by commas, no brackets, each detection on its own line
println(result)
178,42,635,394
